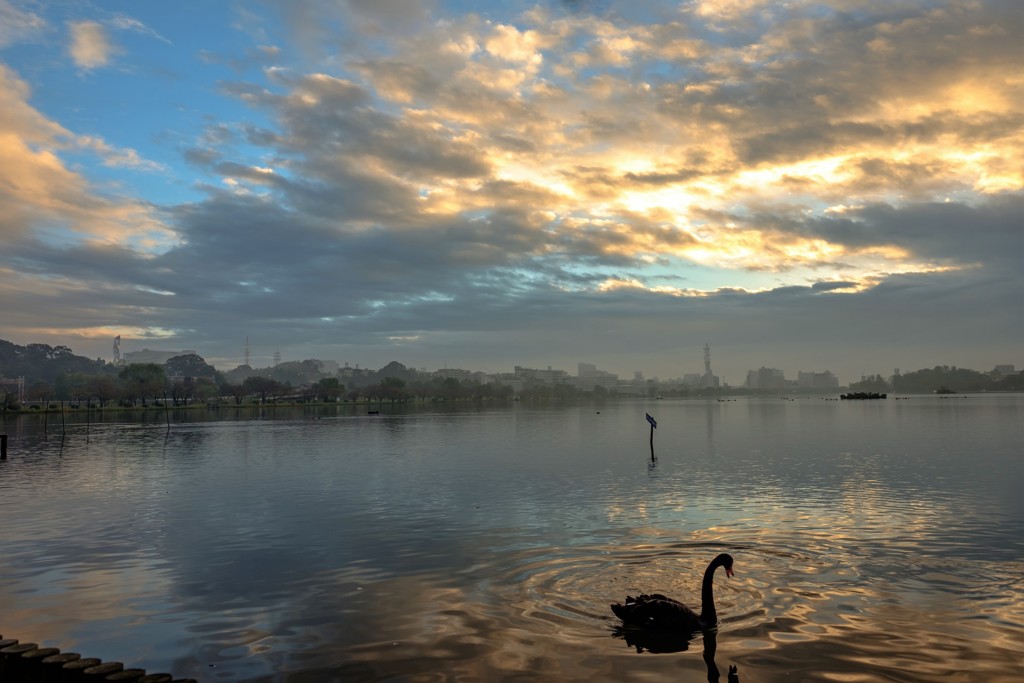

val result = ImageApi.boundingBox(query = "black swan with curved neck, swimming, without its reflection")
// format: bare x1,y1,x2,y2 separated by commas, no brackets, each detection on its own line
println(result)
611,553,732,632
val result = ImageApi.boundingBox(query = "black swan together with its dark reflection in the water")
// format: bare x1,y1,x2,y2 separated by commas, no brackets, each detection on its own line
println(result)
611,553,739,683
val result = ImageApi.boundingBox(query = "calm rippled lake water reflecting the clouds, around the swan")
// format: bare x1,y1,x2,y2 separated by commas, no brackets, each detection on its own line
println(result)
0,394,1024,683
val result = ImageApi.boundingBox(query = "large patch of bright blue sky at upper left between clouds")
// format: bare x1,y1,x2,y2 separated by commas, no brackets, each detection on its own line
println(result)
0,2,288,204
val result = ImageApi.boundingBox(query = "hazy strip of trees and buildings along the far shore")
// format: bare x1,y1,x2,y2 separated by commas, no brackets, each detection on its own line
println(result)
0,340,1024,413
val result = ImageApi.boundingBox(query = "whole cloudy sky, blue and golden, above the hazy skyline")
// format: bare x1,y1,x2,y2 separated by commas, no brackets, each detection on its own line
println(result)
0,0,1024,385
